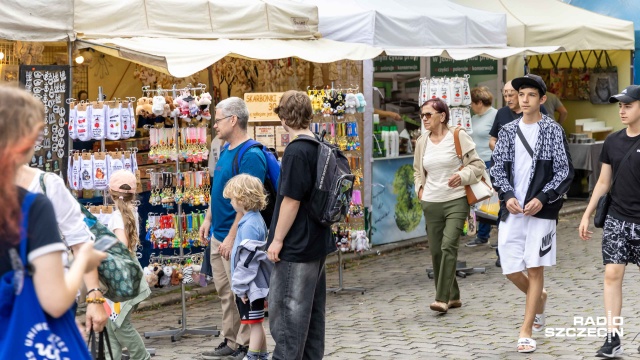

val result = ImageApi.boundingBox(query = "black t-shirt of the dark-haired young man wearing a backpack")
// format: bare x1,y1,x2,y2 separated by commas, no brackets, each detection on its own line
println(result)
267,141,336,263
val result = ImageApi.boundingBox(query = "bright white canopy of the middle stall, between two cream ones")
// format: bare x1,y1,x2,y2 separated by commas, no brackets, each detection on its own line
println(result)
296,0,561,60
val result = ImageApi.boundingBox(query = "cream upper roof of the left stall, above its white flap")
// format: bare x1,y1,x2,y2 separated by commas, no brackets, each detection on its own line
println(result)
0,0,318,41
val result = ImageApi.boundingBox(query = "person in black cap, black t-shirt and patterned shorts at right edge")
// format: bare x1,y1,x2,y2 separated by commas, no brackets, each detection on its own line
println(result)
578,85,640,358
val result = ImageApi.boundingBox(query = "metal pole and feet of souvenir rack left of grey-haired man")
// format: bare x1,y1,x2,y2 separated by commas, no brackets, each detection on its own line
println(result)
143,85,220,341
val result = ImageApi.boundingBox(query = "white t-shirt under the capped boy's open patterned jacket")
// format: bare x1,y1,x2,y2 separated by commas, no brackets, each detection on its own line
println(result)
513,121,540,208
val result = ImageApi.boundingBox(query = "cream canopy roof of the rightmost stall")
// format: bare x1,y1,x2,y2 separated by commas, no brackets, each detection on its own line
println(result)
452,0,634,51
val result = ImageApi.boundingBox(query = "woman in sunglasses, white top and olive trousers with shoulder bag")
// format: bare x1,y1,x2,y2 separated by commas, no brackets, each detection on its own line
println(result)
413,99,485,312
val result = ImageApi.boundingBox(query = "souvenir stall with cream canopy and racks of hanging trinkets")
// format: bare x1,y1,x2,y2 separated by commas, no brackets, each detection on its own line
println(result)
0,1,381,341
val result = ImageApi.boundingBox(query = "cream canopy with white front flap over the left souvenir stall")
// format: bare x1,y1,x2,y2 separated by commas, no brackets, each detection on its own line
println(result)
0,0,382,77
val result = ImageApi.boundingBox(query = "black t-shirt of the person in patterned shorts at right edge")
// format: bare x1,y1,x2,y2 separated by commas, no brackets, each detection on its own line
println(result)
600,129,640,224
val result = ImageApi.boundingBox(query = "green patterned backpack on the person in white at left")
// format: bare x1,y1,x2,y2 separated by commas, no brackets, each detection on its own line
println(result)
40,173,143,302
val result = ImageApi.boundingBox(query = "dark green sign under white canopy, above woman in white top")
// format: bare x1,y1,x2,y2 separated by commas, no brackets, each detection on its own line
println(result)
431,56,498,76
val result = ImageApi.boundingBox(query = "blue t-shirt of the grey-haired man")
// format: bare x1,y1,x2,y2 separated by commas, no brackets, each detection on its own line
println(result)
211,140,267,241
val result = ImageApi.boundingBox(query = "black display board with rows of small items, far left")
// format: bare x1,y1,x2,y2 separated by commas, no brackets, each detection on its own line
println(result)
19,65,70,179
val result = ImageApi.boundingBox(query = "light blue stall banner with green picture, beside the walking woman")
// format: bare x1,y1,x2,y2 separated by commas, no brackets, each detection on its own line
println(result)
371,156,427,245
